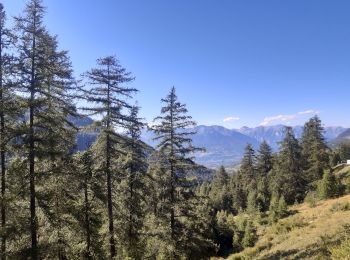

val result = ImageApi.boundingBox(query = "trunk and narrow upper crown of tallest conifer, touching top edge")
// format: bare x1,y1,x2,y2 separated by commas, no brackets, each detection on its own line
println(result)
15,0,45,259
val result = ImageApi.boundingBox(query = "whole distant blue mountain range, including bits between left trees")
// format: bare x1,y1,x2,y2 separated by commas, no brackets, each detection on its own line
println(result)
72,118,350,168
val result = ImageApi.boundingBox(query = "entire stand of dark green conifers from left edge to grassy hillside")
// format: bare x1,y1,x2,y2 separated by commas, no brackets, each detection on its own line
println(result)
0,0,350,259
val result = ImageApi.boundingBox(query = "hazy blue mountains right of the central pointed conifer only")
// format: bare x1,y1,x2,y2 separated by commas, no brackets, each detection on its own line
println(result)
192,125,346,168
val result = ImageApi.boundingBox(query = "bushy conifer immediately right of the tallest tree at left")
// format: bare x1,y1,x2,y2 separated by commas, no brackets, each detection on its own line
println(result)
32,28,77,259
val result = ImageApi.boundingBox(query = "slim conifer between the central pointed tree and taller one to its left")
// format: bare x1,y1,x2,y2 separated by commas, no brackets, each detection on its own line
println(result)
117,106,147,259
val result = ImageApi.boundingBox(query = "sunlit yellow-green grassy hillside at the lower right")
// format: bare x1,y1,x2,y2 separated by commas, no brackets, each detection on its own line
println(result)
229,166,350,259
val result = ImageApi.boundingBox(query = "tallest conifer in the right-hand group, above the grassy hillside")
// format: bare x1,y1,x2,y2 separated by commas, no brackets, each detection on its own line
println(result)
301,116,330,183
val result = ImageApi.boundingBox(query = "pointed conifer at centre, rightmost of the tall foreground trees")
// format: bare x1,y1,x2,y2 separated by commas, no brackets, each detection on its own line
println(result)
153,87,205,259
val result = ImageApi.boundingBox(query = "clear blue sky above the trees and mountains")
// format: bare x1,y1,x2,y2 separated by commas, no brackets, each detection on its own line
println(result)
2,0,350,128
